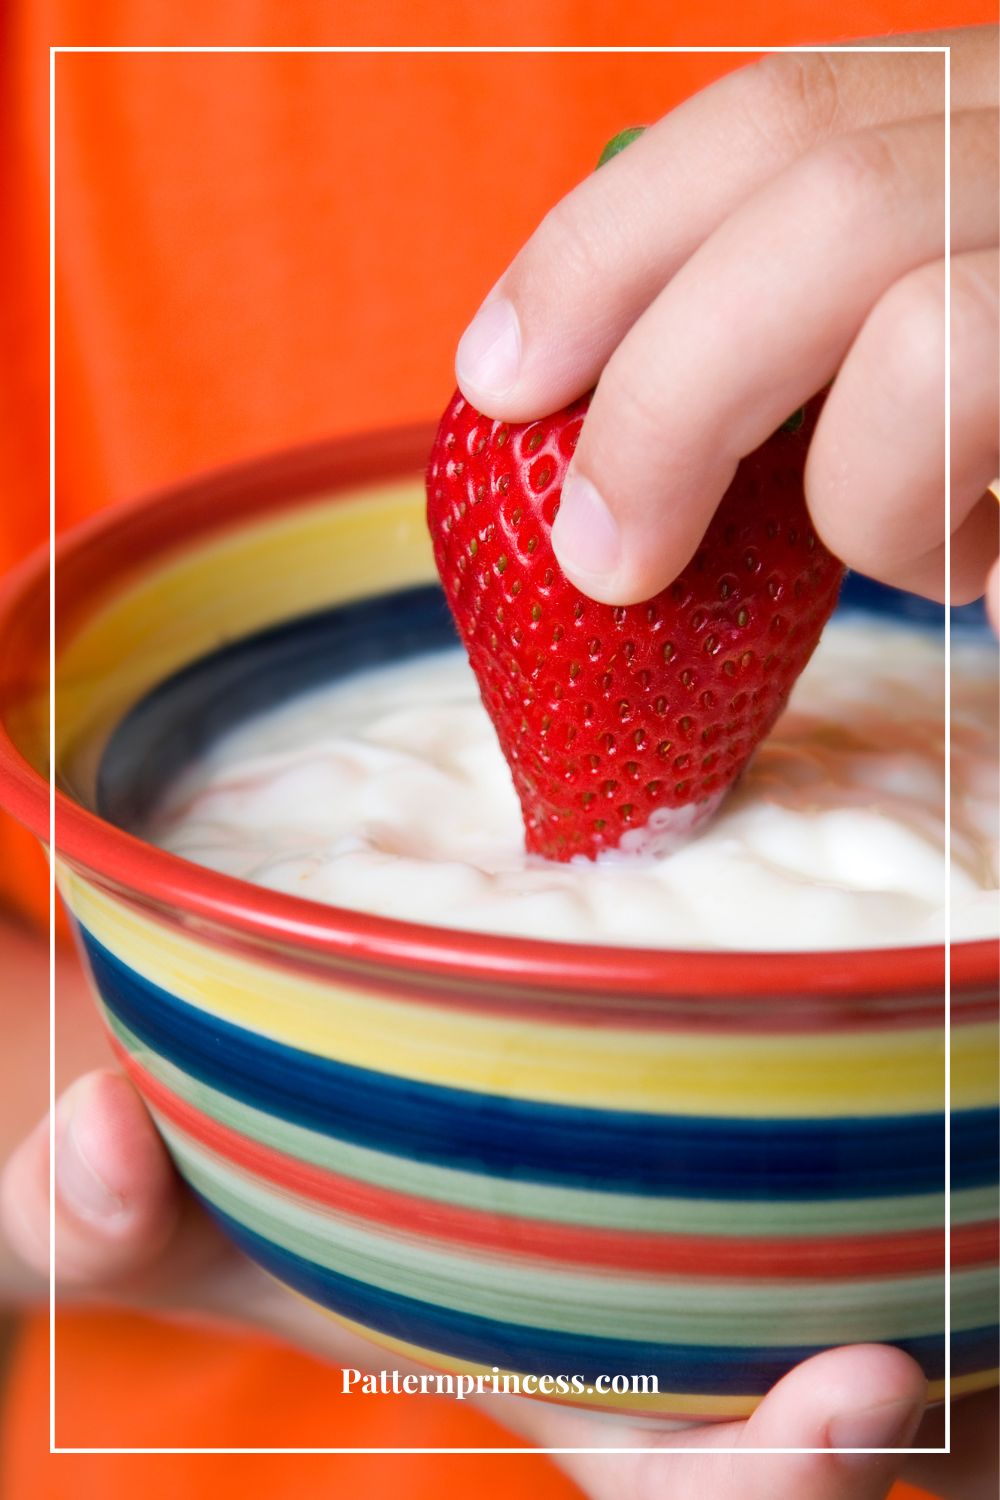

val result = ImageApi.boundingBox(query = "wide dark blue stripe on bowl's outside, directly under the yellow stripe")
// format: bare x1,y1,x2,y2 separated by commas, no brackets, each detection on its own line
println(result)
81,930,997,1200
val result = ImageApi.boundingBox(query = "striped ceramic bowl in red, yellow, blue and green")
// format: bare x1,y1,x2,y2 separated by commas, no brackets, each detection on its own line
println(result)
0,431,997,1421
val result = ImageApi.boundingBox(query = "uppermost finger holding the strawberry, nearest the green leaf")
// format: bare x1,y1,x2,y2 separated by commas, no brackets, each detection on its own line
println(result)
456,29,993,422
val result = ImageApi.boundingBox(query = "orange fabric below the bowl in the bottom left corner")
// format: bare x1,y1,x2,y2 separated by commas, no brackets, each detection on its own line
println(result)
0,1311,579,1476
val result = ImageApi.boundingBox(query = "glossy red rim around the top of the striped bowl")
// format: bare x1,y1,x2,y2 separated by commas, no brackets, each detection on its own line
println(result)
0,423,1000,1004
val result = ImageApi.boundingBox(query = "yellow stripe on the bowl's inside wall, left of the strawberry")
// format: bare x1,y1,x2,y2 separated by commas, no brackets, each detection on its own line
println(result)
55,480,436,801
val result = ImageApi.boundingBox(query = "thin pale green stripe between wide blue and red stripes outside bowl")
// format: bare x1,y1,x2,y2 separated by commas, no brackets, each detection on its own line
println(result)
105,1011,996,1239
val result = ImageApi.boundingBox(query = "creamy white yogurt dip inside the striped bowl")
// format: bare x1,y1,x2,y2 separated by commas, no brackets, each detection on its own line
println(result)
144,617,1000,951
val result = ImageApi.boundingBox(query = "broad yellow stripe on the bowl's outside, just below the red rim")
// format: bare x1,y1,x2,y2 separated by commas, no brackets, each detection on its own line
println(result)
60,867,996,1118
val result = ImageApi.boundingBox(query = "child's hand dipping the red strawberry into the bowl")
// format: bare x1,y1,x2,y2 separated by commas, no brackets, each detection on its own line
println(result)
456,29,999,605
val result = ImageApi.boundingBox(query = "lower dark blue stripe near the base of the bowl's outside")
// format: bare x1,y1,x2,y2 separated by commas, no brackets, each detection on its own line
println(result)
202,1197,997,1395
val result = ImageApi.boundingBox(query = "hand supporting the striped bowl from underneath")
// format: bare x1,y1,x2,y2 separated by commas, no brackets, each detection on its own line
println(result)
0,1071,996,1500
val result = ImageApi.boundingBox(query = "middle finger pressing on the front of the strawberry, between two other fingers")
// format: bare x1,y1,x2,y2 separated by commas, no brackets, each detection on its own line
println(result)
553,111,997,605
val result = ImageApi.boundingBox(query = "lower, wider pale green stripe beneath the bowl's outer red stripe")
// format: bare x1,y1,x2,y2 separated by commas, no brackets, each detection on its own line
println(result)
159,1121,994,1347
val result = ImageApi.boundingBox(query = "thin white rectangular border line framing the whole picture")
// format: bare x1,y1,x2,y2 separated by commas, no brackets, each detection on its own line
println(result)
48,45,952,1457
